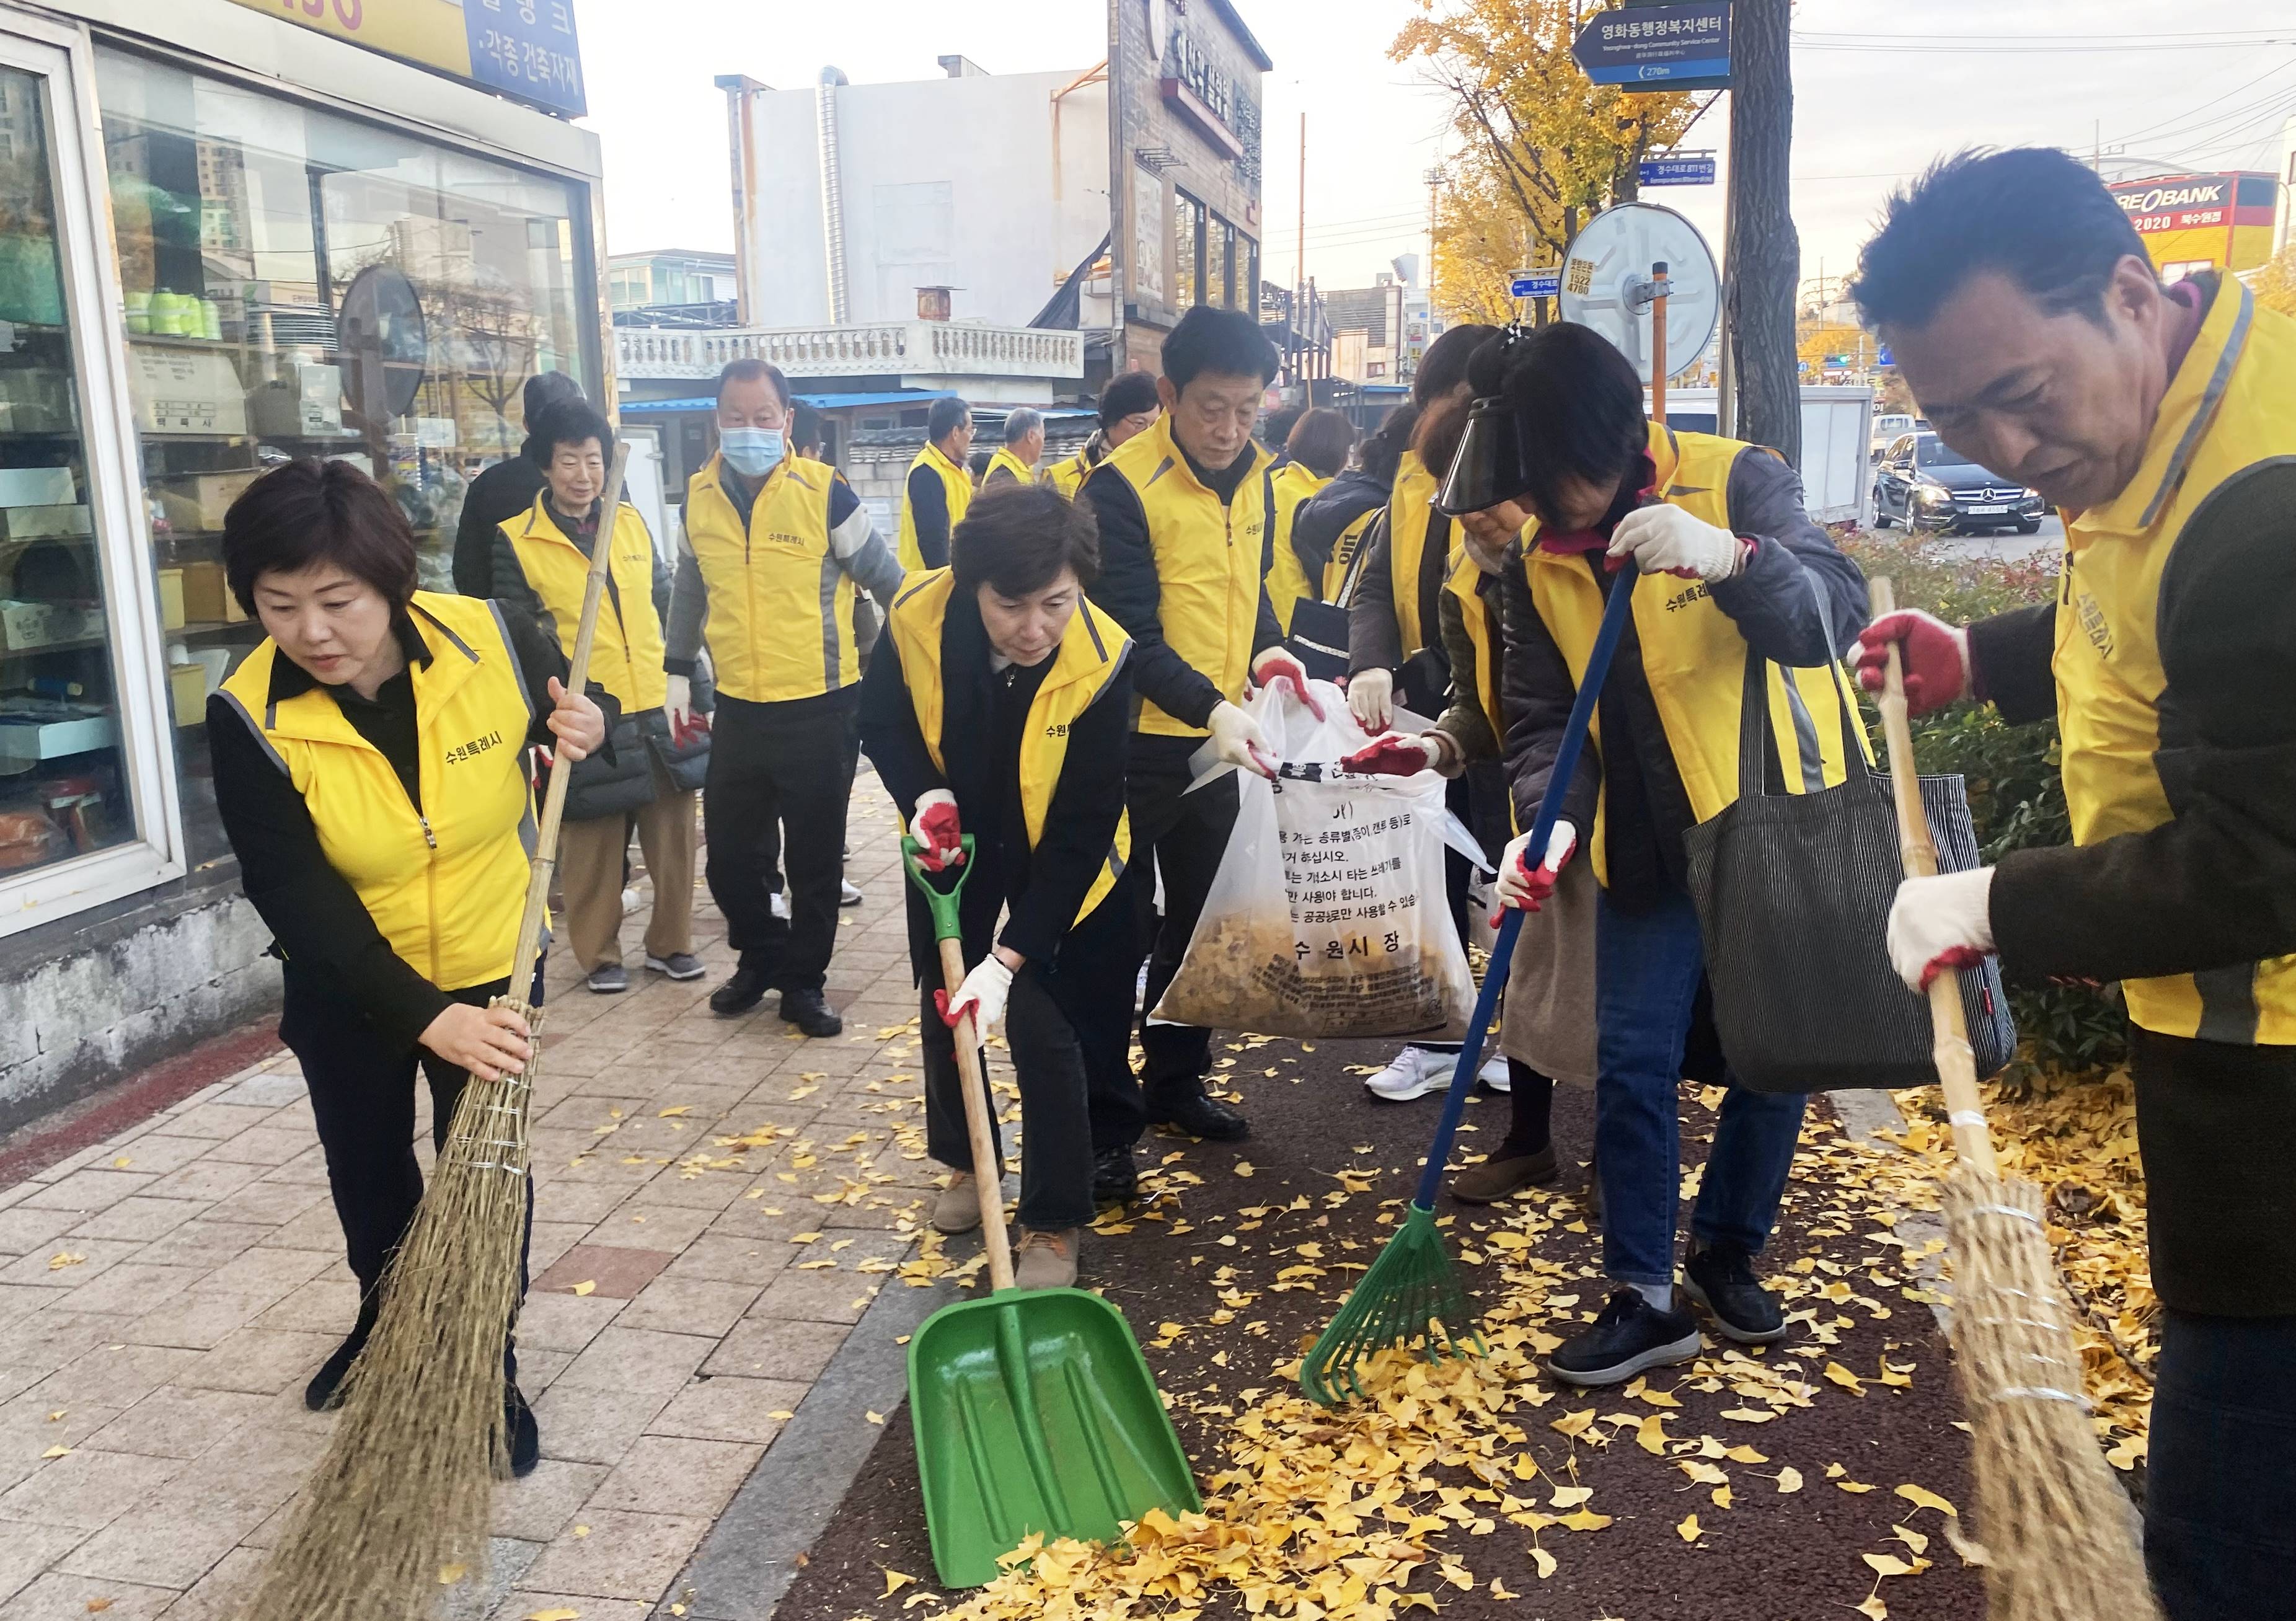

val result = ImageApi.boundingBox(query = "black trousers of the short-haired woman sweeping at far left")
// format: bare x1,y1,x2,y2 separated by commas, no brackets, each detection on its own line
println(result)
280,965,542,1377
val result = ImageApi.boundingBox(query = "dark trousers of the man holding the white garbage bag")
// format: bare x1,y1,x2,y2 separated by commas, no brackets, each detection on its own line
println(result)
1125,733,1237,1116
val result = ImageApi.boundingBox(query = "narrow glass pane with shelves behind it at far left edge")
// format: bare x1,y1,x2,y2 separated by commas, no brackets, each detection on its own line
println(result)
0,64,138,880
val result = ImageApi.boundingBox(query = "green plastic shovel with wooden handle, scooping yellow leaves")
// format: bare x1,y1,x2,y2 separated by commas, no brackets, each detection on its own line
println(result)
900,836,1203,1586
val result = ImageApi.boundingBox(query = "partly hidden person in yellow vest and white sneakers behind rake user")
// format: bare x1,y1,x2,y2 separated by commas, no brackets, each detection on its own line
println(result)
1348,326,1511,1102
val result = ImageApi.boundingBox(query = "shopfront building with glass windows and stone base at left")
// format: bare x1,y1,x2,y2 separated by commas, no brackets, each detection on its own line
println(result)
0,0,613,1129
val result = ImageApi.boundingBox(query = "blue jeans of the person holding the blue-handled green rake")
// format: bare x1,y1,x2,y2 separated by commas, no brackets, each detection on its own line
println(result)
1594,891,1803,1284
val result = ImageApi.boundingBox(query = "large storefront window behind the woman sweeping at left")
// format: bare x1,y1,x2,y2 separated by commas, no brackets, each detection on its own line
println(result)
92,50,597,865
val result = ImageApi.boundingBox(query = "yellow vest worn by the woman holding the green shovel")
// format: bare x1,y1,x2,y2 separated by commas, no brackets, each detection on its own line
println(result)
886,570,1132,923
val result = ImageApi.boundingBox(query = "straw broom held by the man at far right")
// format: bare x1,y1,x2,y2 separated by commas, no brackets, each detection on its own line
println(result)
1873,578,2160,1621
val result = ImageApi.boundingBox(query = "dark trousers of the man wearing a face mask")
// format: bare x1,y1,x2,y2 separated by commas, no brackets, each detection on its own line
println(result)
702,686,861,989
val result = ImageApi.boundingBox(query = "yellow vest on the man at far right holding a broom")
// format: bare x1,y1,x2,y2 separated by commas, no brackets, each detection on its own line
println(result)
2052,275,2296,1047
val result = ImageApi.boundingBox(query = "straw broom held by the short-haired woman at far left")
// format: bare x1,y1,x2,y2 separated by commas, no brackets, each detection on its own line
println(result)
244,443,629,1621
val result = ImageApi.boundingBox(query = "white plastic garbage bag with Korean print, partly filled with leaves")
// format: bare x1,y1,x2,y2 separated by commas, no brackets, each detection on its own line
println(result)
1150,682,1481,1040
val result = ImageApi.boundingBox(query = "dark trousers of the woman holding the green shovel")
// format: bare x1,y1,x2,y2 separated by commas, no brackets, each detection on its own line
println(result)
919,962,1093,1233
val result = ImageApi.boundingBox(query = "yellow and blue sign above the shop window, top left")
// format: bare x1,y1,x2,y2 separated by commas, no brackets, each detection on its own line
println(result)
234,0,590,117
